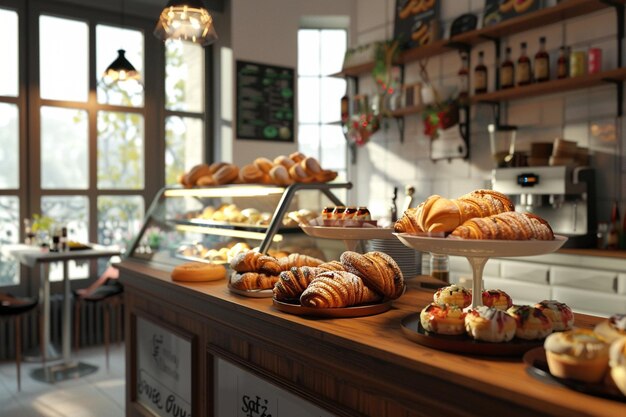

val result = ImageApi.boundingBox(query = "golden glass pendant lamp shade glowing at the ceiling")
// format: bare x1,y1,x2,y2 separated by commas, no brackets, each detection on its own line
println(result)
154,0,217,46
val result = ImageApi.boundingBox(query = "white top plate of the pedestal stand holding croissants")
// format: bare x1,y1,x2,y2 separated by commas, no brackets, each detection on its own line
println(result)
394,233,567,257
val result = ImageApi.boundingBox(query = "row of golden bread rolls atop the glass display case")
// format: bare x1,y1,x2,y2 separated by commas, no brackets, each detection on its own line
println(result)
179,152,337,188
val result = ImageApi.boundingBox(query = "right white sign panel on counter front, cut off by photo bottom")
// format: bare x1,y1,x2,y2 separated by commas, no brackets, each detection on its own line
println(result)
215,357,333,417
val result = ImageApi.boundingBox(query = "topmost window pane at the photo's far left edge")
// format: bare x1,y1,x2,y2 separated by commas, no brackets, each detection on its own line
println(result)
0,9,19,97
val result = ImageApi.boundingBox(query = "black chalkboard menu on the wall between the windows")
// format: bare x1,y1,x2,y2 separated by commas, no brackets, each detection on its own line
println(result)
237,61,295,142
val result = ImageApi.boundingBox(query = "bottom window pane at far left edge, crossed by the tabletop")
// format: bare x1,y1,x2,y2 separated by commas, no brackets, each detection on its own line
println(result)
0,196,20,287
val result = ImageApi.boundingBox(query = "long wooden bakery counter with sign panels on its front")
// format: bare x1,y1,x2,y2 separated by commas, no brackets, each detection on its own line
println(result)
120,260,626,417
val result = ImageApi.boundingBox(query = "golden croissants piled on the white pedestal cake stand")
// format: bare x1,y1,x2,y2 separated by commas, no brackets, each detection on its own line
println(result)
394,190,554,240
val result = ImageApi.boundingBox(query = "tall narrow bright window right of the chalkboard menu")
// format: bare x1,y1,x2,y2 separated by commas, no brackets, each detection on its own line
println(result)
298,29,347,201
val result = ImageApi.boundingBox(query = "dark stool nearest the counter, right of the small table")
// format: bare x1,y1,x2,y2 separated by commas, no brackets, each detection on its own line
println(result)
74,279,124,369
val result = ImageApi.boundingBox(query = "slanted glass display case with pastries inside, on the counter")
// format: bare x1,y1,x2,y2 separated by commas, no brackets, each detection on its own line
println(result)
126,183,352,267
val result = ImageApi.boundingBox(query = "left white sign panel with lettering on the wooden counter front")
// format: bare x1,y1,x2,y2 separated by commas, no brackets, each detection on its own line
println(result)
137,317,191,417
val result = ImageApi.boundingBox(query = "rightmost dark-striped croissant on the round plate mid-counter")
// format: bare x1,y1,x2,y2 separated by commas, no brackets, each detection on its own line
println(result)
340,251,404,300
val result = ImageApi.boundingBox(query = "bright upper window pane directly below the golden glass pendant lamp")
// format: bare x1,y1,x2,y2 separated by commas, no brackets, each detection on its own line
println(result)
165,42,204,113
